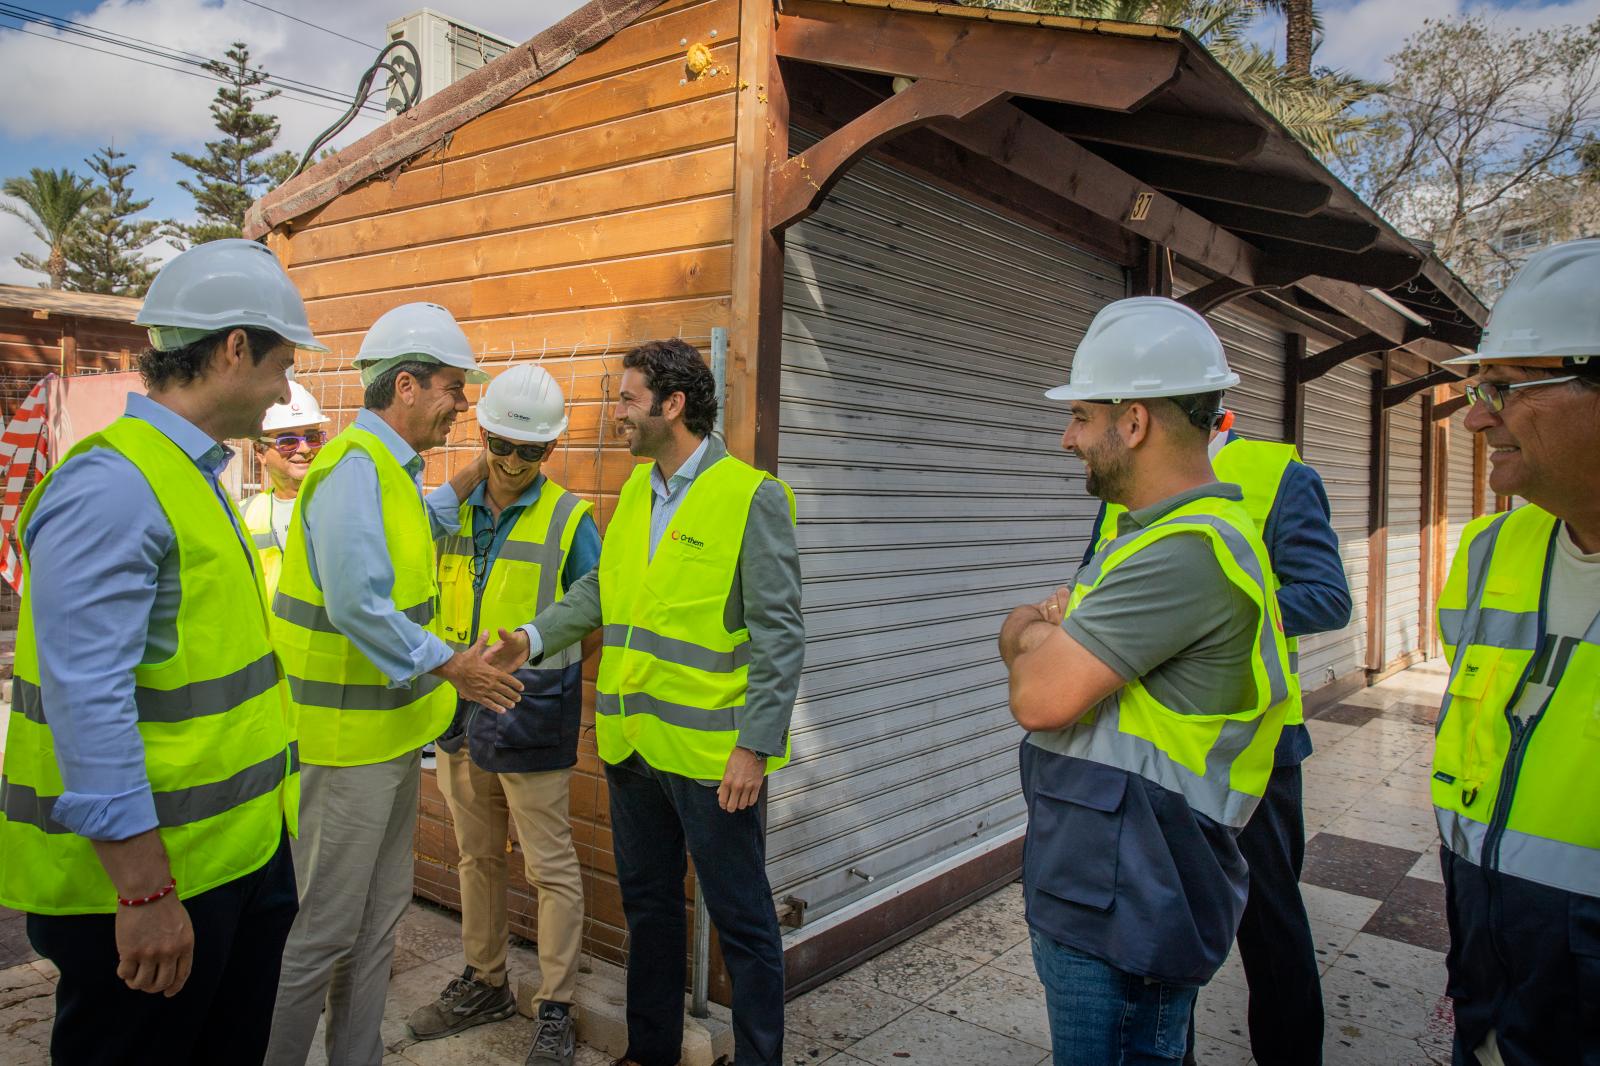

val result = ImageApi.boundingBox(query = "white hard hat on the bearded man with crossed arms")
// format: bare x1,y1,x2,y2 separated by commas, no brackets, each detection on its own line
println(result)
1045,296,1238,400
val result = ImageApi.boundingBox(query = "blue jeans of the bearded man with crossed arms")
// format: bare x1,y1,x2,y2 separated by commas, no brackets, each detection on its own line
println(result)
1029,930,1200,1066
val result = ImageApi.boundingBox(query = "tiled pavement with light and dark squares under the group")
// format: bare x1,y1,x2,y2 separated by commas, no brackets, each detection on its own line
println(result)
0,659,1451,1066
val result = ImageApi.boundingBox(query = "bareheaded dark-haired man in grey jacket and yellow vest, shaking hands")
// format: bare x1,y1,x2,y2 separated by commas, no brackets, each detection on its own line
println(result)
491,339,805,1066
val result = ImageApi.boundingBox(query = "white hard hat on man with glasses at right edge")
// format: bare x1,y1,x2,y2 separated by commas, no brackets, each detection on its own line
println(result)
1442,237,1600,367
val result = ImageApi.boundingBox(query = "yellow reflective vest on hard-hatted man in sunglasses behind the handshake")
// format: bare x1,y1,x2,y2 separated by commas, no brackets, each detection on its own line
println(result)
438,480,594,671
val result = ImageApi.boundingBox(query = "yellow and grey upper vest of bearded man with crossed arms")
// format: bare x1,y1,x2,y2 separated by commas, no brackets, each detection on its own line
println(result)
1027,498,1290,829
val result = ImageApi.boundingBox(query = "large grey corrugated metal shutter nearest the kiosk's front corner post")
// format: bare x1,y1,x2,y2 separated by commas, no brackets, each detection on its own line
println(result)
766,131,1125,917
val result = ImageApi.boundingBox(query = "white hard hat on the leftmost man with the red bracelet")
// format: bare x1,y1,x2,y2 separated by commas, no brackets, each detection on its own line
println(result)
133,238,328,352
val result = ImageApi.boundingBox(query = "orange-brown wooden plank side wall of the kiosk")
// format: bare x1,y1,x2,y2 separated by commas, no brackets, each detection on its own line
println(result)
269,0,739,960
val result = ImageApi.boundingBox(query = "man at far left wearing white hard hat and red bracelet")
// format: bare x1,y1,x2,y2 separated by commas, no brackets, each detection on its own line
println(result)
0,240,328,1066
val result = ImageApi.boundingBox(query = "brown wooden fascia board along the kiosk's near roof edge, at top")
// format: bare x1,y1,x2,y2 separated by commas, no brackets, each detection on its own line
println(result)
778,0,1184,112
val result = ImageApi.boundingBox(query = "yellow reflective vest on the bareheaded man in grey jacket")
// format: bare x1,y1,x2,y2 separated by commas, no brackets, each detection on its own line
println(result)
595,456,794,779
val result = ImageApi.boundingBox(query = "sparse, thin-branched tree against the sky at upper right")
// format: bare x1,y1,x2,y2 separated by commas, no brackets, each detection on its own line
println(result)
1339,16,1600,295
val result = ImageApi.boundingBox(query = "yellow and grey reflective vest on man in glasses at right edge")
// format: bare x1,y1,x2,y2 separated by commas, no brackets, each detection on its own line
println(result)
1430,504,1600,896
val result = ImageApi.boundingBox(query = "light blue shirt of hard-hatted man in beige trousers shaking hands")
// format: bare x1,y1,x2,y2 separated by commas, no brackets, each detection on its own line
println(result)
304,410,461,688
